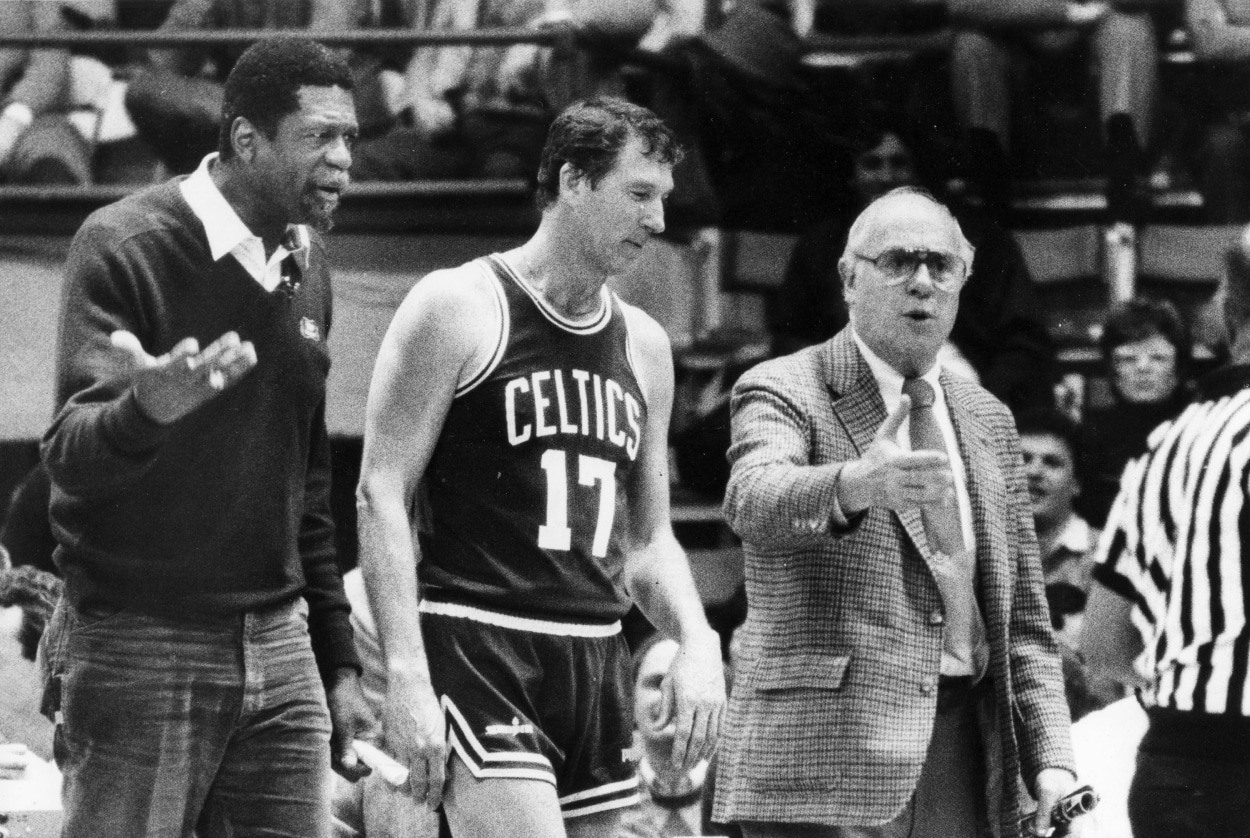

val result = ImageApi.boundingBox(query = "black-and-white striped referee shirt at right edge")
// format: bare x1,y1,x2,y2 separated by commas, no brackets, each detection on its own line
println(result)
1095,366,1250,717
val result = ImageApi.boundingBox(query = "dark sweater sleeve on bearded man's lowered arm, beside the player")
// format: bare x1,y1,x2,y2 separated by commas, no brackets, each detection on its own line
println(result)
300,400,361,680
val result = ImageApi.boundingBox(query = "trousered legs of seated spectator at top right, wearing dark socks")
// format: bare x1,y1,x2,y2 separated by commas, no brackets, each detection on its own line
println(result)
950,0,1158,220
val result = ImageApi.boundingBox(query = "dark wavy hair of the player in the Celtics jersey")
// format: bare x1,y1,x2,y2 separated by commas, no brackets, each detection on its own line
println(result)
535,96,685,210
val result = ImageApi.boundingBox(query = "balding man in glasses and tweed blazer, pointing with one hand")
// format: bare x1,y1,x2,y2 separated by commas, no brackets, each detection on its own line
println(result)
715,188,1076,838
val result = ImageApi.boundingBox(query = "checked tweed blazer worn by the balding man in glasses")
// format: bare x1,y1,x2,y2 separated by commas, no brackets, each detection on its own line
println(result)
715,329,1074,838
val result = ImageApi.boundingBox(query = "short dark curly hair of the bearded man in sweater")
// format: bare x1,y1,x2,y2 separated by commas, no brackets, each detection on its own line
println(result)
218,38,353,160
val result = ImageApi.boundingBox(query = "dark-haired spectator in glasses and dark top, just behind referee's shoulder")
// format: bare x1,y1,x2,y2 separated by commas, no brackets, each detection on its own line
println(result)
1079,298,1190,527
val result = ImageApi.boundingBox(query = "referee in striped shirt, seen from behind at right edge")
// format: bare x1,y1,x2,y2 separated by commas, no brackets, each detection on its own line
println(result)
1083,228,1250,838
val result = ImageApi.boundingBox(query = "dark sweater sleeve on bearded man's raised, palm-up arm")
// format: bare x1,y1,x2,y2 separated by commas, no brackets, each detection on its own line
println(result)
43,219,169,495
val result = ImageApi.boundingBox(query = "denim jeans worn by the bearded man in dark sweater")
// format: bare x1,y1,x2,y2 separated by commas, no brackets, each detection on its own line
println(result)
44,599,331,838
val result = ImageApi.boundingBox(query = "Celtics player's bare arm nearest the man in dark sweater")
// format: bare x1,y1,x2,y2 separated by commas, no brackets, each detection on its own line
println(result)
356,270,498,808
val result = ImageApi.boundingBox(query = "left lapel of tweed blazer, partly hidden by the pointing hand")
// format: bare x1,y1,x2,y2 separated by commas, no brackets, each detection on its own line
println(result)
823,326,929,563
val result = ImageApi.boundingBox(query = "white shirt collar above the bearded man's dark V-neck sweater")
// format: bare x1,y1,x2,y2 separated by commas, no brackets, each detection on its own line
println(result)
181,151,309,291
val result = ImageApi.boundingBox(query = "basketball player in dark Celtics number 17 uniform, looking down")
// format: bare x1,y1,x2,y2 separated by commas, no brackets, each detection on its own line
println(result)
359,99,725,838
